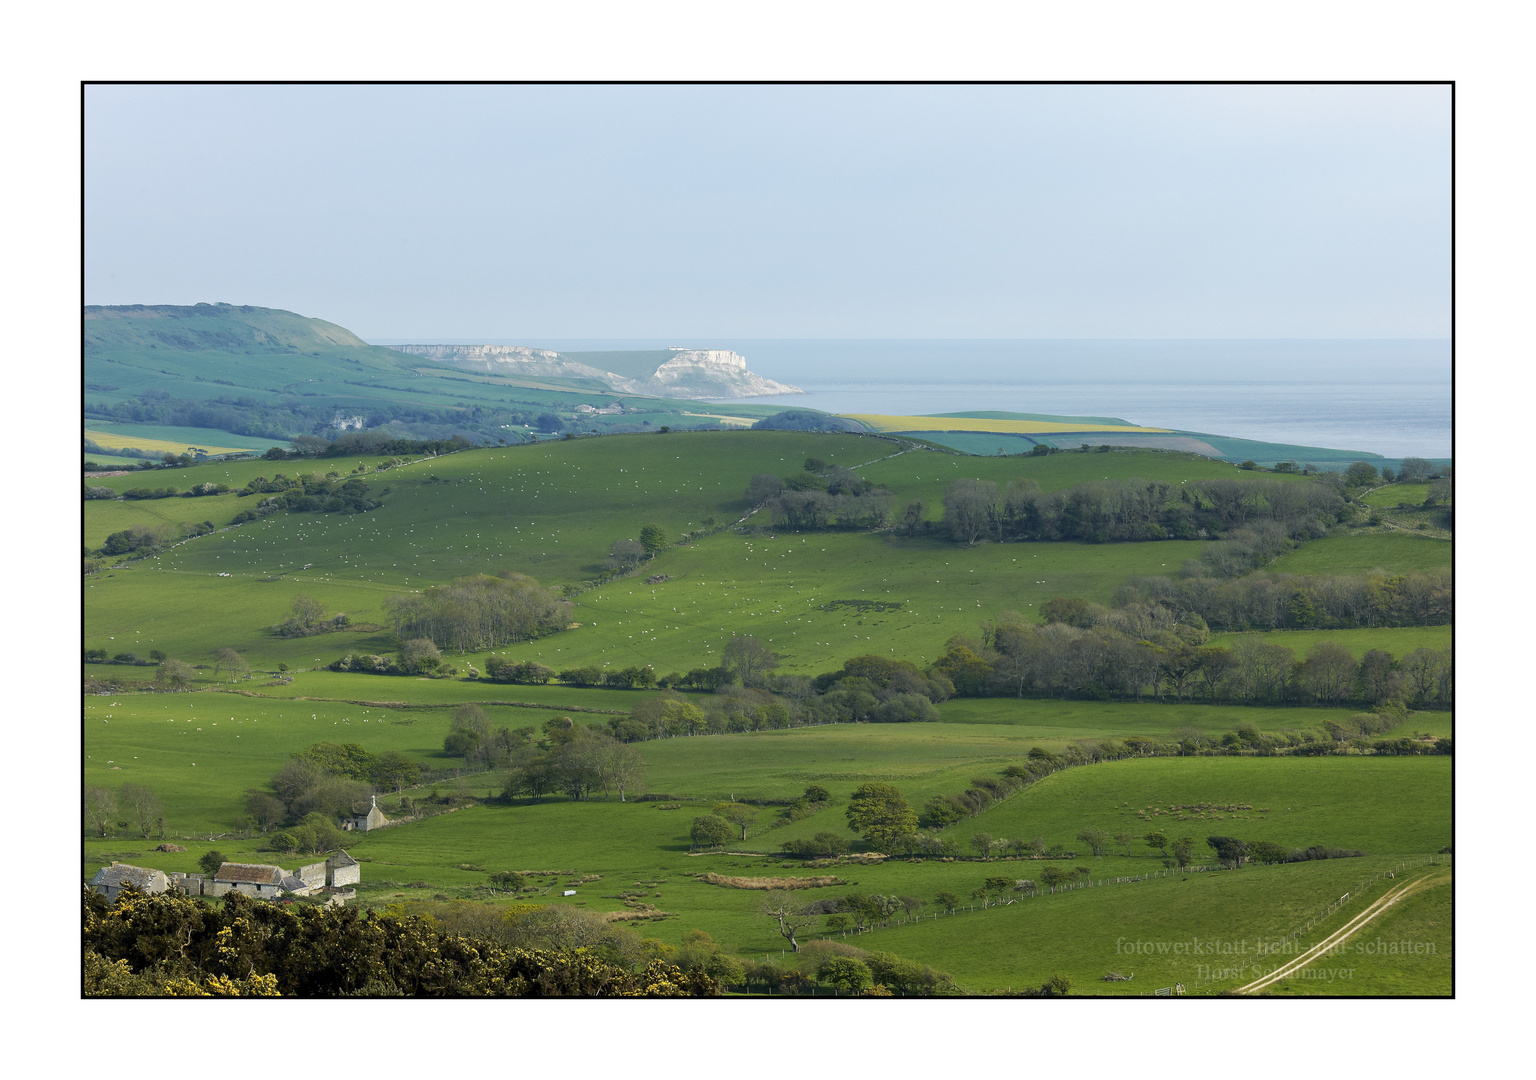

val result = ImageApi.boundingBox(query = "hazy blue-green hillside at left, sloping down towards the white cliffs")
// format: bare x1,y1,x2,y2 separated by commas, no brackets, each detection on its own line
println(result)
83,304,804,447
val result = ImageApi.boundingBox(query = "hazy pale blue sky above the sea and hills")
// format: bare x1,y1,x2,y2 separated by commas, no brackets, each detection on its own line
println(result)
84,86,1452,341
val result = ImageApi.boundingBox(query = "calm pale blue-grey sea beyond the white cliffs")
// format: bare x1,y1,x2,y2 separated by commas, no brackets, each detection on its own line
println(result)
379,336,1452,461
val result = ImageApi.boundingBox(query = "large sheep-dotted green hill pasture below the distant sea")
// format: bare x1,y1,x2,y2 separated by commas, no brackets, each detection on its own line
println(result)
86,432,1259,673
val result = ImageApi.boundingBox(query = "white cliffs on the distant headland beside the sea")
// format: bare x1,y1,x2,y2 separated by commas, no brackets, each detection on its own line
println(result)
392,346,805,398
